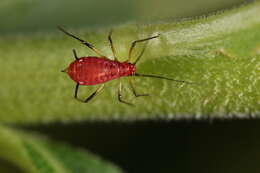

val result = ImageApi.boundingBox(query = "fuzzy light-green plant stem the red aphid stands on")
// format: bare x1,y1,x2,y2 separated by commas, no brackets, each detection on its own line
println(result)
0,2,260,123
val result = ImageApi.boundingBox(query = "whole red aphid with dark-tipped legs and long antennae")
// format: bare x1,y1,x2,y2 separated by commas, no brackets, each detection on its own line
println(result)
58,27,193,105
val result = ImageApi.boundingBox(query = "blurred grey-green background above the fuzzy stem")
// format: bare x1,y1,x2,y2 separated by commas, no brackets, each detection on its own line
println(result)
0,0,252,34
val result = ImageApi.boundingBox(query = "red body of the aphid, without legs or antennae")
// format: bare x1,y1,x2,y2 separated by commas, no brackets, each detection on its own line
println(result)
65,56,135,85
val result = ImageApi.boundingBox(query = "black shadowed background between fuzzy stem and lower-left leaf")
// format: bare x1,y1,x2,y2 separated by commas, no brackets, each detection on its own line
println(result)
21,120,260,173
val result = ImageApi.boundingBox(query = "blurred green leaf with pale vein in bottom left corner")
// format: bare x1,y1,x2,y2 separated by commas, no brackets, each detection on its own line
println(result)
0,126,122,173
